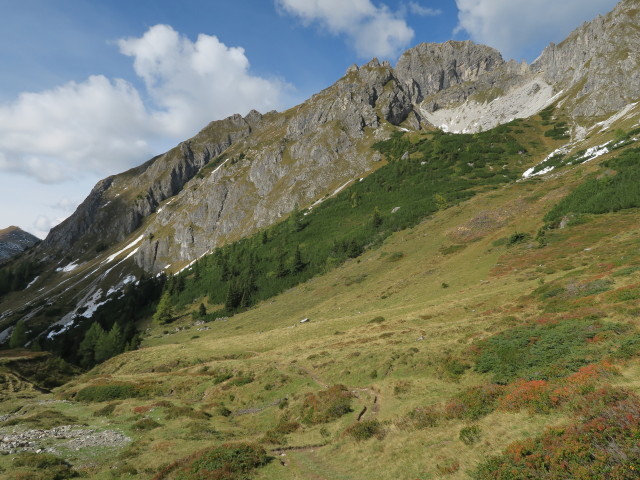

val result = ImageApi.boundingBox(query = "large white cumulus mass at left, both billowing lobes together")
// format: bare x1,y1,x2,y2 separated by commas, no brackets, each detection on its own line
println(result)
0,25,286,185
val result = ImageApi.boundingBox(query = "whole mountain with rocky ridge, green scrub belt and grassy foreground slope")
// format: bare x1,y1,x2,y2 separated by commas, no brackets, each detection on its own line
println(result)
0,0,640,480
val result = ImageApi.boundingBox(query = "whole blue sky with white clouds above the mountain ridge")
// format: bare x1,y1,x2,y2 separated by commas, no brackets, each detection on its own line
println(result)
0,0,617,238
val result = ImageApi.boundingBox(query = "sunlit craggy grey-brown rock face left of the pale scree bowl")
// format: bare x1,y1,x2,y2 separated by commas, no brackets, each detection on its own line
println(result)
135,59,419,272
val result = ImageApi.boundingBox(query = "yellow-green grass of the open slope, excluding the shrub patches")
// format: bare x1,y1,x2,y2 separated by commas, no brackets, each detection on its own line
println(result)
0,113,640,480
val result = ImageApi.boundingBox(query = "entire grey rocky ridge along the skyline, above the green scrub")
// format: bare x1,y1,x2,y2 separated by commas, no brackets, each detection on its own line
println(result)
26,0,640,273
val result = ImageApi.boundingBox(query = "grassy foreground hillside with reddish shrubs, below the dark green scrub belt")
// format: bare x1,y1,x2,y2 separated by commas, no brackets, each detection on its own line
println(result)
0,105,640,479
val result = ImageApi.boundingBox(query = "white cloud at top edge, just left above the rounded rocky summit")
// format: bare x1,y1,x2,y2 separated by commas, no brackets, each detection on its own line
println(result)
276,0,414,58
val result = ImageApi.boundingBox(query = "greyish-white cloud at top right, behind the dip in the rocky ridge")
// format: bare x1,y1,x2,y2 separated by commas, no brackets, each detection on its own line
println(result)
456,0,618,59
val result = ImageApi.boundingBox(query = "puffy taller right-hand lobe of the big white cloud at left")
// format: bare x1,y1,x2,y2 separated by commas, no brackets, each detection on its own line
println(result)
118,25,288,137
